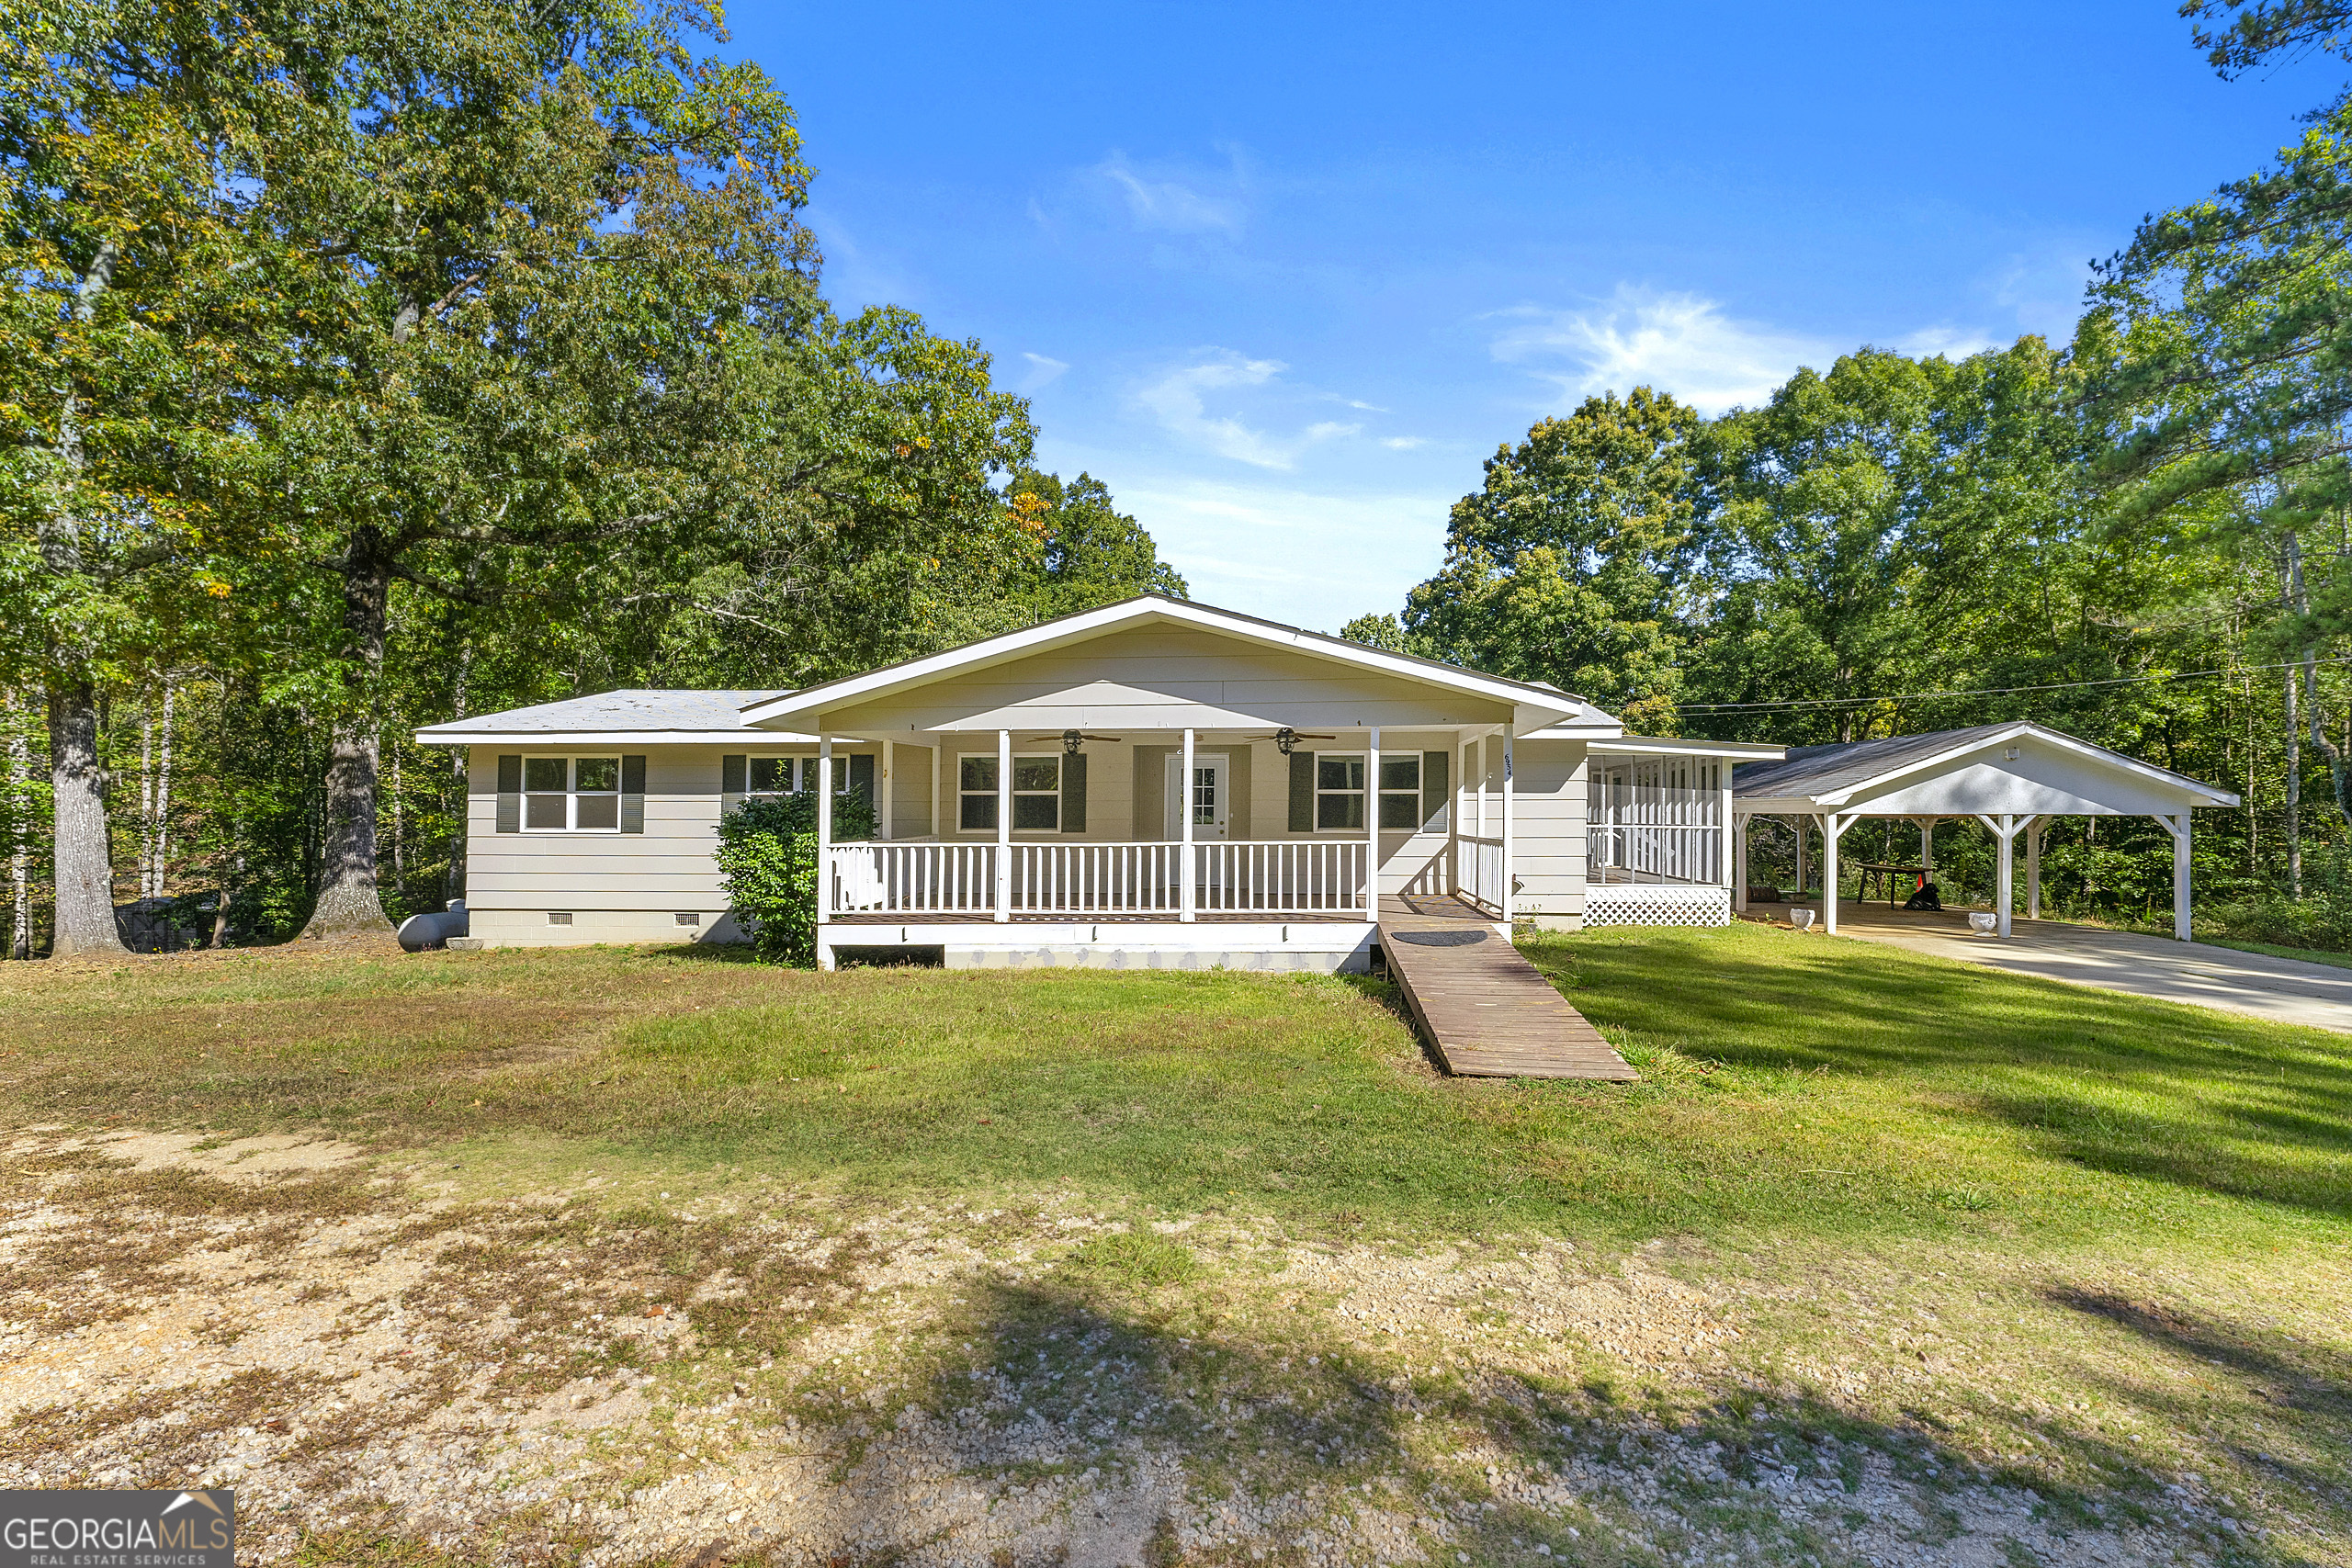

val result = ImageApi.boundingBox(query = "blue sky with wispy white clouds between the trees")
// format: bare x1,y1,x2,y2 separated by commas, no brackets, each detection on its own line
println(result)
727,0,2340,630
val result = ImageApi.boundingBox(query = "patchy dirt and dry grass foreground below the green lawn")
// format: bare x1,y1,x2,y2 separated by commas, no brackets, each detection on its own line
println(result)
0,1131,2314,1568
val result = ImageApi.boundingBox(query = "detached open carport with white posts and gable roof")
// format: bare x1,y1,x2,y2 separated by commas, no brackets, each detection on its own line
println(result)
1731,722,2237,942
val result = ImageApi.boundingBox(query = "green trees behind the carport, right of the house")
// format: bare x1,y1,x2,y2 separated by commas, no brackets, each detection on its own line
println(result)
1345,0,2352,947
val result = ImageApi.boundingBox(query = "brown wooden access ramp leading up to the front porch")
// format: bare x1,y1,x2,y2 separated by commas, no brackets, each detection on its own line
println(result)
1381,894,1639,1084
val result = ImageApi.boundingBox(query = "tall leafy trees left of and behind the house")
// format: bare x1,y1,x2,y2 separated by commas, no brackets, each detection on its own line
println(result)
0,0,1183,957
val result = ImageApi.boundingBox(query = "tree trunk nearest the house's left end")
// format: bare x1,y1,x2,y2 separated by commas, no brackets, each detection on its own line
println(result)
297,526,393,942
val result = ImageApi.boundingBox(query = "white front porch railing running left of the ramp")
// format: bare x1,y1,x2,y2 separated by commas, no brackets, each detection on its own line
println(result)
823,840,1366,919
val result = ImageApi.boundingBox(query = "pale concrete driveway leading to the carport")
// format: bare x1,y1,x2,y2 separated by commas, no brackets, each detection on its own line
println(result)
1750,903,2352,1034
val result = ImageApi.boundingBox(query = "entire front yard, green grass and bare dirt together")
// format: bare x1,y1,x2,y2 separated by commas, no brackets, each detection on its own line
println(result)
0,929,2352,1568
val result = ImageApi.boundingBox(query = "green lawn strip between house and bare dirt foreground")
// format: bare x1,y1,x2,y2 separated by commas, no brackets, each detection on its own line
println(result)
14,924,2352,1241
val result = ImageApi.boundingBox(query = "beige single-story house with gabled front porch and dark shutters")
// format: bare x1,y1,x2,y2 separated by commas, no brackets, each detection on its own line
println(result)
416,594,1781,968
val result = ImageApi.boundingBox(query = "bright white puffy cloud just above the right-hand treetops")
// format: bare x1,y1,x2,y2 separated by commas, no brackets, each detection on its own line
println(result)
1494,285,1837,413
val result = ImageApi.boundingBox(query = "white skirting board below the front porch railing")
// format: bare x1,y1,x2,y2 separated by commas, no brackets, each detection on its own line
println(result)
816,919,1376,974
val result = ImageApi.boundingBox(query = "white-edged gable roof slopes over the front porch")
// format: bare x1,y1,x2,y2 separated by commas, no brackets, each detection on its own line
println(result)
743,592,1623,736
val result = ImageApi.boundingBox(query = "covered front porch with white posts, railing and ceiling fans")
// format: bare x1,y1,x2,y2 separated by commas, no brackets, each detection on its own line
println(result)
811,722,1515,941
